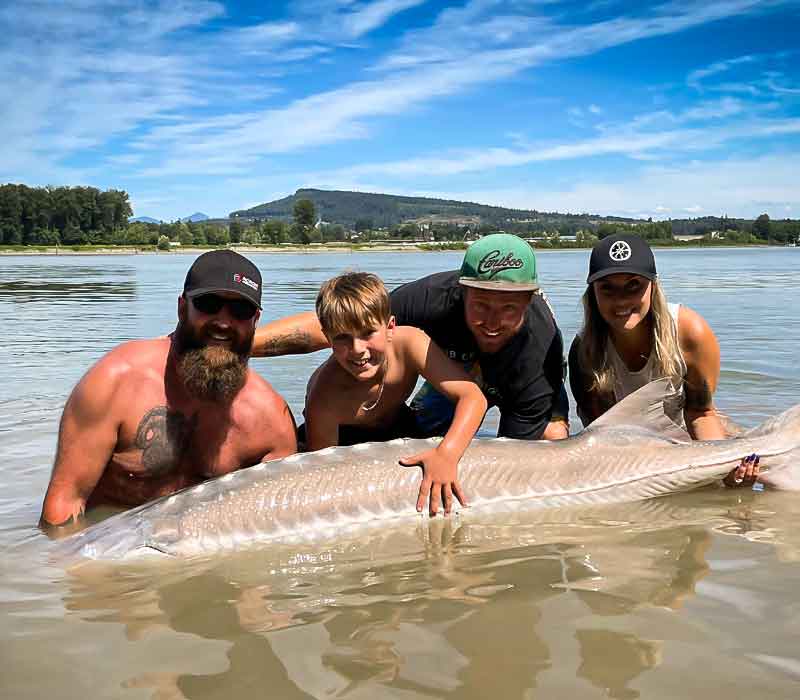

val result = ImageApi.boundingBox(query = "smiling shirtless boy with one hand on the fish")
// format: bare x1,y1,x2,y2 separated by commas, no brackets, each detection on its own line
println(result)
305,272,487,515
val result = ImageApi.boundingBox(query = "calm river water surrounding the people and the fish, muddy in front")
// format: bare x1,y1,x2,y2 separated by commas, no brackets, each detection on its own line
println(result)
0,248,800,700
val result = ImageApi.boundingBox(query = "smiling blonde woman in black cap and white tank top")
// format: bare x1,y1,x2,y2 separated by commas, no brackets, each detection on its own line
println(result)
569,234,758,486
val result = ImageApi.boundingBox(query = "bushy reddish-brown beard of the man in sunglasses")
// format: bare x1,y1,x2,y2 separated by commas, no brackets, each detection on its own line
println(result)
175,319,255,403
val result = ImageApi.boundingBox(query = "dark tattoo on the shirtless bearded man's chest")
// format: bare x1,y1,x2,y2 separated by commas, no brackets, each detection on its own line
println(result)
134,406,197,476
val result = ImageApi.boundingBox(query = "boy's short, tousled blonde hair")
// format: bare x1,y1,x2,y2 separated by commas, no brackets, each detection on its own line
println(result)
316,272,391,338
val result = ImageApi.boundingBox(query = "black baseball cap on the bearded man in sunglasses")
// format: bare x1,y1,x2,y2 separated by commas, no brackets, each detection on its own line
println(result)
183,250,261,309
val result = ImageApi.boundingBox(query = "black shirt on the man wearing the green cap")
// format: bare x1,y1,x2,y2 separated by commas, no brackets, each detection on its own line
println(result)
391,271,569,440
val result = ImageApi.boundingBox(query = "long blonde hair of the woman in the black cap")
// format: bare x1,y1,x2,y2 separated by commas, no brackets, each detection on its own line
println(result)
578,280,683,397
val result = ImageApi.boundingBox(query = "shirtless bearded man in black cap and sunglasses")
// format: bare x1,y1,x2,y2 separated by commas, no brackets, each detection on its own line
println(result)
41,250,297,527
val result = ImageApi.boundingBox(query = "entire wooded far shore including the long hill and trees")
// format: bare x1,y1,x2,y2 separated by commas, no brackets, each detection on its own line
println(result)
0,183,800,249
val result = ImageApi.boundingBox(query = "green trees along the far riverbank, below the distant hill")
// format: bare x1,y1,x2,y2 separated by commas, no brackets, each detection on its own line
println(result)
0,184,800,249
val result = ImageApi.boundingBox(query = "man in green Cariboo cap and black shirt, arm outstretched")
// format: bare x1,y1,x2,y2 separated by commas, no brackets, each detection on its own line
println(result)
253,234,568,440
